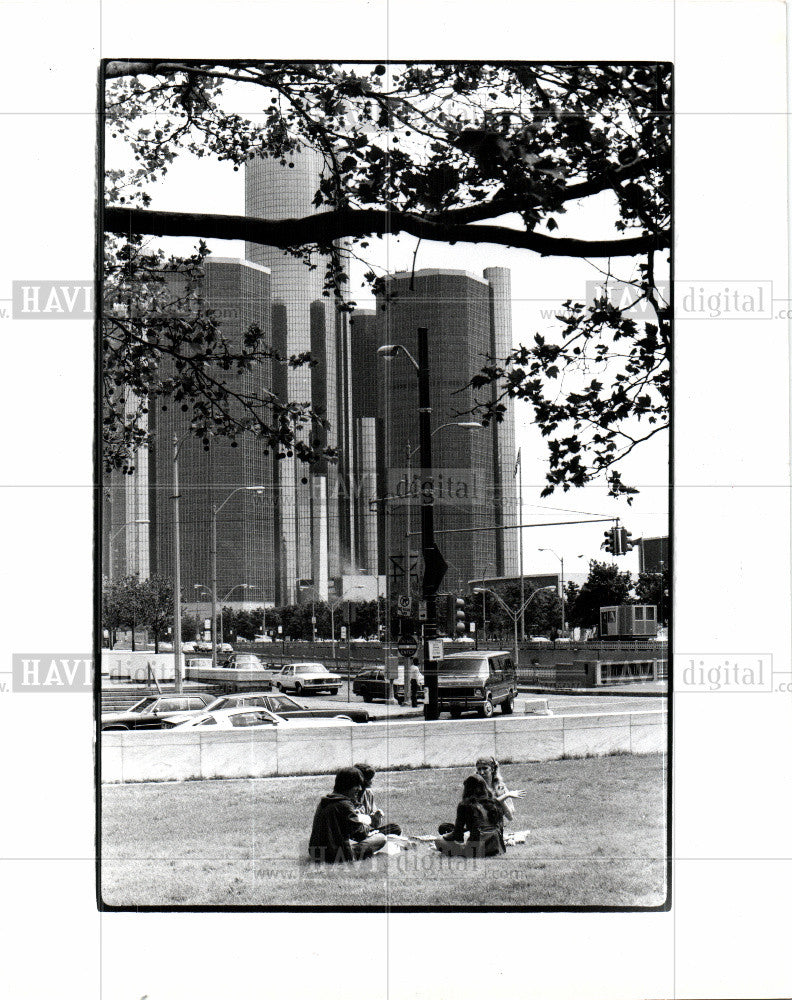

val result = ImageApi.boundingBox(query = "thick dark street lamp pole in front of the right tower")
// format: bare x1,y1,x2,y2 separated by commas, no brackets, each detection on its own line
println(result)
377,327,448,719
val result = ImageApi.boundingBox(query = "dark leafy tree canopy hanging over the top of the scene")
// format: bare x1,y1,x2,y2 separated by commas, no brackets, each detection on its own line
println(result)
104,61,671,497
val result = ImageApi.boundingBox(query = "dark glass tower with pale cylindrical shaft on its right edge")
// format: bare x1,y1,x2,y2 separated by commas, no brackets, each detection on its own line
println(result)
372,268,519,592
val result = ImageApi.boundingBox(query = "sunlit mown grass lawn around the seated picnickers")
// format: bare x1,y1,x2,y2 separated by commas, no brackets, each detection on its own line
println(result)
101,754,666,906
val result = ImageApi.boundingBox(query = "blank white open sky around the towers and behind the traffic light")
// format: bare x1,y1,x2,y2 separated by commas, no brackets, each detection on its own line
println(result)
106,74,669,580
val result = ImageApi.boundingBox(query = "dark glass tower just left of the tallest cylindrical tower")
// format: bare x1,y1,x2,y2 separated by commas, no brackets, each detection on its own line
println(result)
148,257,282,606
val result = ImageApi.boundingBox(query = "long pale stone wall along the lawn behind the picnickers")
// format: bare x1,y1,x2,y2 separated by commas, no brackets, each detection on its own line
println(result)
101,710,667,782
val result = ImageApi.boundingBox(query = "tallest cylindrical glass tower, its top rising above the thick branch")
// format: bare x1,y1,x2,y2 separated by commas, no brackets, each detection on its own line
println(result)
245,148,356,601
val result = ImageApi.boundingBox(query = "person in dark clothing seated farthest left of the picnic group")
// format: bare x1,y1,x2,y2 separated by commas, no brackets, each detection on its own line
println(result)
308,767,387,864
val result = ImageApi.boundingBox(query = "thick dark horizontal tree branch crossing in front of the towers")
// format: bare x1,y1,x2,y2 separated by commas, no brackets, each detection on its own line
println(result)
104,206,669,257
